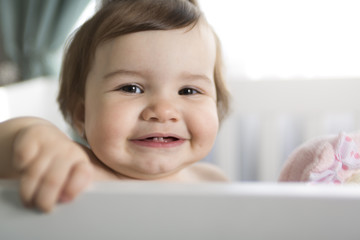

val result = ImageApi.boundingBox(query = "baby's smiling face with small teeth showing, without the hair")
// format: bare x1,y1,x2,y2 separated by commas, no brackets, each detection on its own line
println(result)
85,24,219,179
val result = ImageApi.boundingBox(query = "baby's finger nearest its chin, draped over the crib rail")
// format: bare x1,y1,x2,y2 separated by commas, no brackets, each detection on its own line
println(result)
59,162,93,203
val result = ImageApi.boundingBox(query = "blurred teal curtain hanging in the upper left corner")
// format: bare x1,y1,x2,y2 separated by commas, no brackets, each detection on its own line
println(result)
0,0,89,79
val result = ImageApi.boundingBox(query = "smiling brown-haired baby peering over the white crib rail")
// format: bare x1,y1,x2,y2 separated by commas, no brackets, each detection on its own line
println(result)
0,0,229,211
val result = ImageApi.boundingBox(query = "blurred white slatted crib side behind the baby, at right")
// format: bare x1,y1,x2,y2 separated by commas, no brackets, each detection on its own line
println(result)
213,79,360,181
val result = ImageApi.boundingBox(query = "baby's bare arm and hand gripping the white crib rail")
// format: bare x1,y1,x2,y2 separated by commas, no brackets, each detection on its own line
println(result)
0,117,93,211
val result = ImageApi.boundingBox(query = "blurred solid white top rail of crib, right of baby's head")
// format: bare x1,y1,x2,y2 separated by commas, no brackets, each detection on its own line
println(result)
228,79,360,115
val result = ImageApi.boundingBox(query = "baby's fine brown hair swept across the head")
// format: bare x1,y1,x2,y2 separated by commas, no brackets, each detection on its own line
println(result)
58,0,229,131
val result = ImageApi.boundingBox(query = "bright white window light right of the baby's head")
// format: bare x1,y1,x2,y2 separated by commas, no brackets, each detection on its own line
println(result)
199,0,360,80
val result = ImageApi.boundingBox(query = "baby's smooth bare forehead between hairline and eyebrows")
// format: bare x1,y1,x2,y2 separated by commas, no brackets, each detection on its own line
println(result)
86,24,216,85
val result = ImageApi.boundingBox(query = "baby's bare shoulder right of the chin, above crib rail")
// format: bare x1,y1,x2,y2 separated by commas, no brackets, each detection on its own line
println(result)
188,163,229,182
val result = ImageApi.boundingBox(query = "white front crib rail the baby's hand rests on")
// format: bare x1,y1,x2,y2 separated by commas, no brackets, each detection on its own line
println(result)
0,181,360,240
